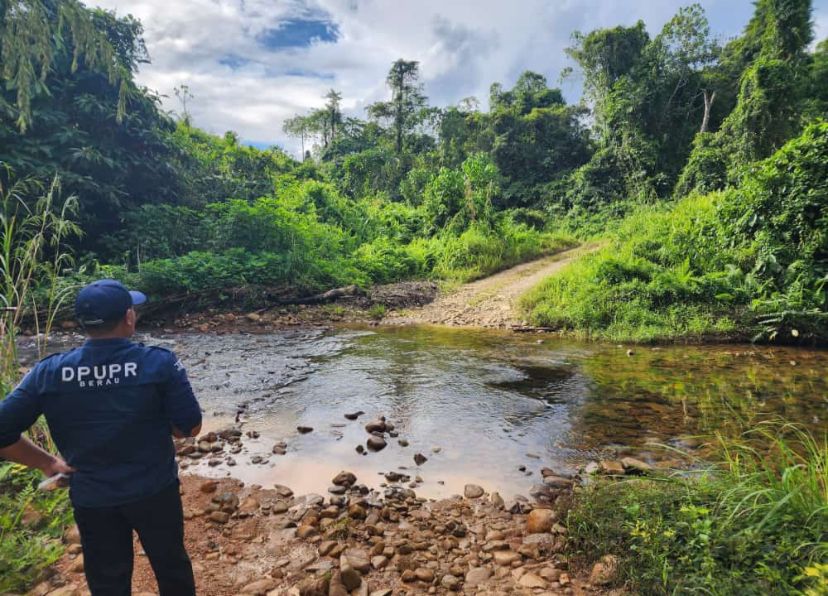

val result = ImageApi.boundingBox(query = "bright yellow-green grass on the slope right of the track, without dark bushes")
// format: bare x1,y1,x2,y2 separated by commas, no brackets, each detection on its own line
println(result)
520,196,744,342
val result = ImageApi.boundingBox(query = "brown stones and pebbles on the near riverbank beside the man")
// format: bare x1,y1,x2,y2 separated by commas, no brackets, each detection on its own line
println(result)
35,420,672,596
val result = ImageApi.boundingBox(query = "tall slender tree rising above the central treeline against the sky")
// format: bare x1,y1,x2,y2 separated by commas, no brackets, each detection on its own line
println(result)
368,59,427,154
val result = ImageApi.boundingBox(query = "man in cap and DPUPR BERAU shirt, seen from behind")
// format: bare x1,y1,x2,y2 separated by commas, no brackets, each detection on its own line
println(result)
0,280,201,596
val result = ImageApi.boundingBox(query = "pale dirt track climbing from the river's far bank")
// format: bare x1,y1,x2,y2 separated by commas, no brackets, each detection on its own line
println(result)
383,244,599,328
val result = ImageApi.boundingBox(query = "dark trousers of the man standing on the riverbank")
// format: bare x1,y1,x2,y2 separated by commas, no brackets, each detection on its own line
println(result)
74,483,195,596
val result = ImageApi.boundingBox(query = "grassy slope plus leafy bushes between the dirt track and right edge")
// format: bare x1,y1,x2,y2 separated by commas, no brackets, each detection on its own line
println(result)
524,122,828,341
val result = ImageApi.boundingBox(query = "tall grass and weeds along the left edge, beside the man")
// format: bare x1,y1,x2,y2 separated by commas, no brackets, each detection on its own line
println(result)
0,172,80,593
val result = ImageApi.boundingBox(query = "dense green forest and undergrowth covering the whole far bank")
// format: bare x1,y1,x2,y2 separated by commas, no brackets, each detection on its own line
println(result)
0,0,828,322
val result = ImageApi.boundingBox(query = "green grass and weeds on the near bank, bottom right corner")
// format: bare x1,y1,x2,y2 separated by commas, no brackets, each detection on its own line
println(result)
568,423,828,596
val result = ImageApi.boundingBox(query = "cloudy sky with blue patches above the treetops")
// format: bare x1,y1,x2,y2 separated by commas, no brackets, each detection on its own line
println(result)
88,0,828,153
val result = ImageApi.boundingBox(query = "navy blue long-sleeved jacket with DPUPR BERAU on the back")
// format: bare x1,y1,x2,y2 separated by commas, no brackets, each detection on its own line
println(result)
0,339,201,507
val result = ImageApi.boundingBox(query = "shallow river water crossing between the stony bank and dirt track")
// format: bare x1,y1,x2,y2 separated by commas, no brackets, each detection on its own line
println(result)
151,327,828,498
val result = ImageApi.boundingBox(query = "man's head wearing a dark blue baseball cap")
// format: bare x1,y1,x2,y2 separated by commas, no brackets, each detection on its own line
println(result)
75,279,147,338
